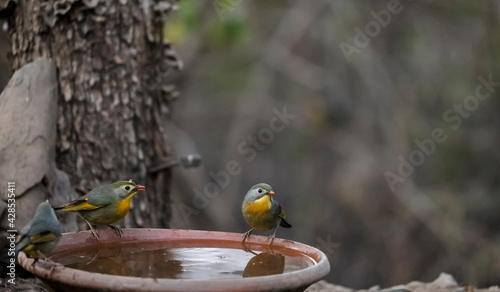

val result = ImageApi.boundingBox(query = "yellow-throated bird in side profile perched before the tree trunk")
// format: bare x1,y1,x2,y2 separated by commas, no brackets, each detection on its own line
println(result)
54,180,146,239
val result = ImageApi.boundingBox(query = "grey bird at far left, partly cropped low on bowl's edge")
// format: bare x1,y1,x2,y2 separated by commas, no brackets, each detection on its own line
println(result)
16,202,61,258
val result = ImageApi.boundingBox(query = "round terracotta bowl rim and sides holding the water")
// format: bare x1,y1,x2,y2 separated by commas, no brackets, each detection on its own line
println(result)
18,228,330,292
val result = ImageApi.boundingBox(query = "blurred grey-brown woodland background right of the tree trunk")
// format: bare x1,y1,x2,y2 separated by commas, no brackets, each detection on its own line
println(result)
0,0,500,288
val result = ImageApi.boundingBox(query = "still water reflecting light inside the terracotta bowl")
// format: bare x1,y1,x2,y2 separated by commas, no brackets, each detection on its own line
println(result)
51,243,316,280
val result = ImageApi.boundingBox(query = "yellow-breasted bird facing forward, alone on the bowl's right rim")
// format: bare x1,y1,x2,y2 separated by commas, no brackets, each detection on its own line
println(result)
241,183,292,245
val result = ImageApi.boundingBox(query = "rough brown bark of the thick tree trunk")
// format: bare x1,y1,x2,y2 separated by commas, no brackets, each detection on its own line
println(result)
5,0,180,227
